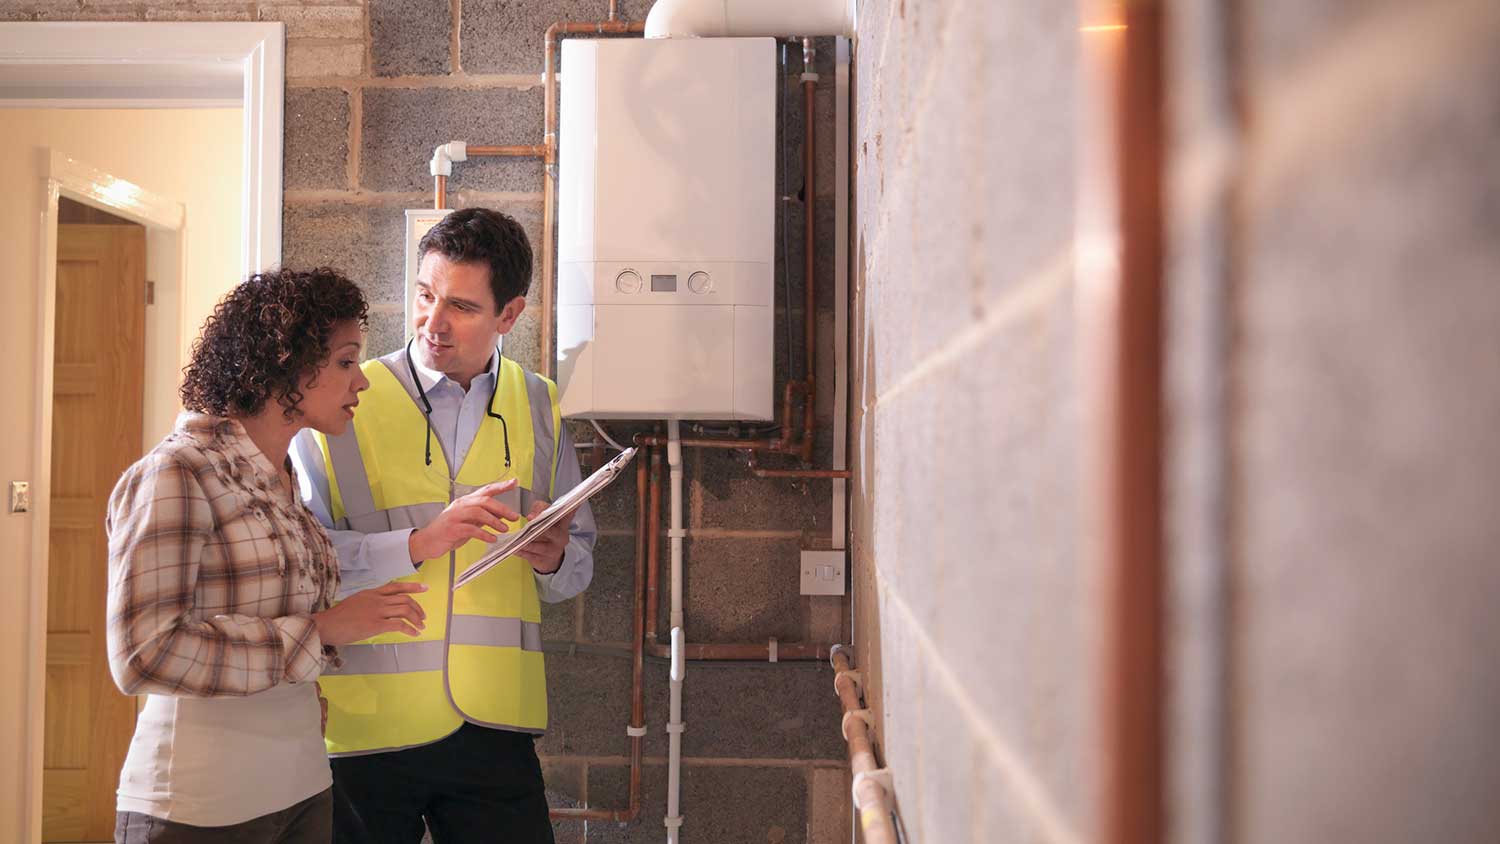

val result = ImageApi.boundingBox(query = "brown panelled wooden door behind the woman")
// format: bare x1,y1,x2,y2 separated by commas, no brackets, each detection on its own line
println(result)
42,225,146,841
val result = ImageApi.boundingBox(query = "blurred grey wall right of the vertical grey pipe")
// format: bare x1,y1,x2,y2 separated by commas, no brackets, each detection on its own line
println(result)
1229,0,1500,843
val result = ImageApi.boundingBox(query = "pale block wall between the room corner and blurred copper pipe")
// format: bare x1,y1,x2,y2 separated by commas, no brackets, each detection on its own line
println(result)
852,3,1098,843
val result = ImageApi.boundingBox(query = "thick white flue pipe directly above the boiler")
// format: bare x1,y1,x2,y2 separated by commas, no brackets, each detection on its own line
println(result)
647,0,855,37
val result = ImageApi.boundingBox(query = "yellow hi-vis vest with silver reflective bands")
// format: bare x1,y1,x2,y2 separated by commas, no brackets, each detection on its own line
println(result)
318,355,561,756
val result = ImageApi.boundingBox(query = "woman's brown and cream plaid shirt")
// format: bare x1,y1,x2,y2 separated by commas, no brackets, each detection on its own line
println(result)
105,414,339,697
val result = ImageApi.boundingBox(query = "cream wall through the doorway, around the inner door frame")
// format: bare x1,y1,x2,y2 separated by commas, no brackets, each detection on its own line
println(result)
0,108,242,841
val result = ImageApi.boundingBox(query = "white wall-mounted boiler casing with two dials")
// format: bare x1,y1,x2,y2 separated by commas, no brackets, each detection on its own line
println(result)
557,37,776,420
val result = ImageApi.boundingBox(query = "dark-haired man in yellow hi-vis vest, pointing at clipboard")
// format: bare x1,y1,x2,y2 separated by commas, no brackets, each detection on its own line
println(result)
294,208,596,844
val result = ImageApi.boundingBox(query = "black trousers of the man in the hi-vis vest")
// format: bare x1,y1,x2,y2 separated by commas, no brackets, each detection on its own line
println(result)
330,724,554,844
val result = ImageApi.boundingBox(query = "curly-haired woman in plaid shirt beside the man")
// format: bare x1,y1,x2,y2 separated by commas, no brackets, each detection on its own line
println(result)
107,270,423,844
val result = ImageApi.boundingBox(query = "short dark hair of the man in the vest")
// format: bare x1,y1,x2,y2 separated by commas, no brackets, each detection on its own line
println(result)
417,208,531,312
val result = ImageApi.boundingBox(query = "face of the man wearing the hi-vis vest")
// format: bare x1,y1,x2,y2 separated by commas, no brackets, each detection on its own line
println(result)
411,252,527,388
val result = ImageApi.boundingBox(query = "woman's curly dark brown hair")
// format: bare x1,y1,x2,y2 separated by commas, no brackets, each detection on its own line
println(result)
180,267,369,420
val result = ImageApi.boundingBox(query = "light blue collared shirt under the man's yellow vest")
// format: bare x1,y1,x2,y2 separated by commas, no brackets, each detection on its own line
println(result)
291,349,599,603
